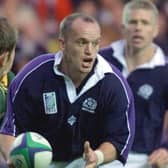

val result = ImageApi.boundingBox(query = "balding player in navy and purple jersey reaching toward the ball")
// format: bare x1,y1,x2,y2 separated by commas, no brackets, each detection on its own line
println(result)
0,13,135,168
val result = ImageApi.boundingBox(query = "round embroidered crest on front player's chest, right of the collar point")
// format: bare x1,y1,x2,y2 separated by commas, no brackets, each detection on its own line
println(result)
82,97,97,113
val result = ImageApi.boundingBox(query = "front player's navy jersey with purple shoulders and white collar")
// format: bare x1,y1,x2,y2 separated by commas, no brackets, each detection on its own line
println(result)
0,51,134,163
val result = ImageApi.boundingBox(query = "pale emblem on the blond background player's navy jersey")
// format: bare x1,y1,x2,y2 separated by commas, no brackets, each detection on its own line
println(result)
137,84,153,100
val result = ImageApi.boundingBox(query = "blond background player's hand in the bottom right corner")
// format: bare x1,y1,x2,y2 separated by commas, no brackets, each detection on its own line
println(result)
148,148,168,168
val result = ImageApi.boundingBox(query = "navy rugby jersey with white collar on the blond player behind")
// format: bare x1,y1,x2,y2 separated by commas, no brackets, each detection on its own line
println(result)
100,40,168,154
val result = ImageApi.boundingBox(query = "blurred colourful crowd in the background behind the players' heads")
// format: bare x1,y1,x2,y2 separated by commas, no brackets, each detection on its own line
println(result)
0,0,168,74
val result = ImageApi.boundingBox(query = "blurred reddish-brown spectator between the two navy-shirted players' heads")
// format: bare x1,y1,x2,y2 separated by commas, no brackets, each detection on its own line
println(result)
98,0,124,47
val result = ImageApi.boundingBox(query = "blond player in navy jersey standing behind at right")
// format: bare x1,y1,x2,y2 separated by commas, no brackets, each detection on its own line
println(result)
100,0,168,168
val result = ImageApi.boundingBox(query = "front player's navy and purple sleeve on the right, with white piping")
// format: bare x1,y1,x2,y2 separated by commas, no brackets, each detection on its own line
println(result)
101,66,135,164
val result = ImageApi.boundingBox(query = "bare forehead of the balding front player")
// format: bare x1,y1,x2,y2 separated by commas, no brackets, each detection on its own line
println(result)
72,18,101,39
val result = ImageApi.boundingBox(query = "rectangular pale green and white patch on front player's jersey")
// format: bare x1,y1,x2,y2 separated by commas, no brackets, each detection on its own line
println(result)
43,92,57,114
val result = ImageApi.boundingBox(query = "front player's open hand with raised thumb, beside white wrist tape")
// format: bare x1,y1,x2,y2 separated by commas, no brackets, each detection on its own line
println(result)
83,141,98,168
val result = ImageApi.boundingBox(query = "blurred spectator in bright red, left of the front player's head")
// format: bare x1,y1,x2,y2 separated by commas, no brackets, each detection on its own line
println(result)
34,0,73,36
